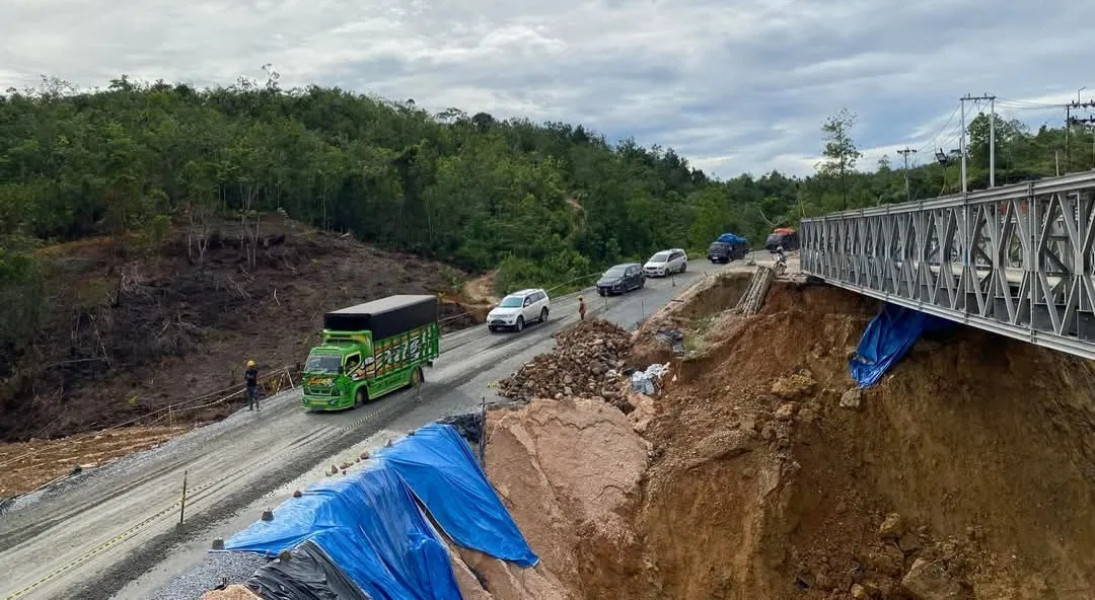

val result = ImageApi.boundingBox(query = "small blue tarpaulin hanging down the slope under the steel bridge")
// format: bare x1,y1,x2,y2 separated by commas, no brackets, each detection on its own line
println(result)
849,304,953,388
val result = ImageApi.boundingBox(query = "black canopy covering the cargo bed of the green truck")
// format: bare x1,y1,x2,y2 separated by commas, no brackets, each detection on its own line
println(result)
323,296,437,339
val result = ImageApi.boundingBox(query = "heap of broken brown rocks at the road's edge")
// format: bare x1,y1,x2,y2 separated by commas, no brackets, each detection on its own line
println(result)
498,320,631,412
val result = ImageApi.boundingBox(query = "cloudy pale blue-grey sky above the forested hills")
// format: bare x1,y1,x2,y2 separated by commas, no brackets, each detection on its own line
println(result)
0,0,1095,177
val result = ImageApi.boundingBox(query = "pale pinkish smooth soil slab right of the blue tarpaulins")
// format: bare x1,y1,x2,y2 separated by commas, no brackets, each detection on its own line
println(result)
473,399,649,599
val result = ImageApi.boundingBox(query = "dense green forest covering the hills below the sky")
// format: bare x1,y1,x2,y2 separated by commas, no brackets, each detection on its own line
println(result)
0,76,1095,295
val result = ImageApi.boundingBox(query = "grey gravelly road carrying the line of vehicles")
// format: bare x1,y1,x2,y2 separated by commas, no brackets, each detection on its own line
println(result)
0,261,739,600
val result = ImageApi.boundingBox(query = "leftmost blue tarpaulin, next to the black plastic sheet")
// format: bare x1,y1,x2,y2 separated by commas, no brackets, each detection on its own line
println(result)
224,464,460,600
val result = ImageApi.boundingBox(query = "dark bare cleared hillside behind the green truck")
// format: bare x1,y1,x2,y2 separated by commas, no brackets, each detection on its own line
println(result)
0,216,482,440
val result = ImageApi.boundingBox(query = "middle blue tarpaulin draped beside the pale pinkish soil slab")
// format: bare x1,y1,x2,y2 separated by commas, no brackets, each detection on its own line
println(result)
373,424,540,567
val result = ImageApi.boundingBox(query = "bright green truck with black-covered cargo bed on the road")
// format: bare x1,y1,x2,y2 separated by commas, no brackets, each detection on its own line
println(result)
301,296,440,411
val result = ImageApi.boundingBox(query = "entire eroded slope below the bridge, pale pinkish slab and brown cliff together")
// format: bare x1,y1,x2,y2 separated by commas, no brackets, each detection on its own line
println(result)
487,282,1095,600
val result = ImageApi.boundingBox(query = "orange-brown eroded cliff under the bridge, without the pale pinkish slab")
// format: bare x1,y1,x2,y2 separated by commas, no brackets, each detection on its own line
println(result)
637,285,1095,598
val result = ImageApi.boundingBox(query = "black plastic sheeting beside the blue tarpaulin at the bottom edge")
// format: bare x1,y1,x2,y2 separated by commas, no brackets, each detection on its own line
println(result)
246,541,371,600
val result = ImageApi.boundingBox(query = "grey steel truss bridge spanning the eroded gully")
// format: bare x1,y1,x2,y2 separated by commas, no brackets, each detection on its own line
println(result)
799,172,1095,359
